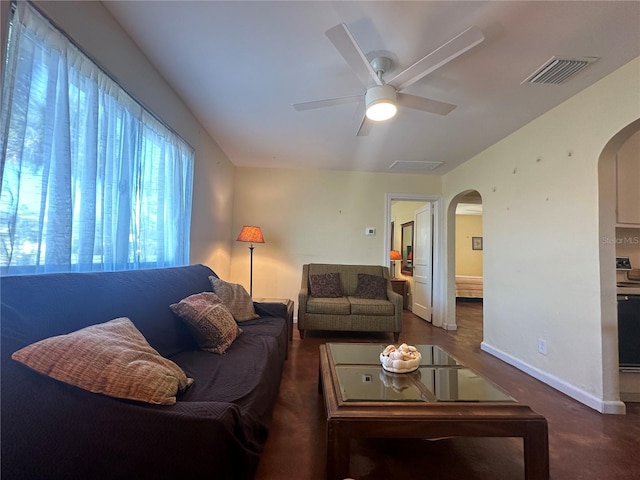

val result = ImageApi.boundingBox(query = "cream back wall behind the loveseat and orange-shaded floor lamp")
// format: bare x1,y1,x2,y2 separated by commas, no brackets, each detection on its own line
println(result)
231,168,441,304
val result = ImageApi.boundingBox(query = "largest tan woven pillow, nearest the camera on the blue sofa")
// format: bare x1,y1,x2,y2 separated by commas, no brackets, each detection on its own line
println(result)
11,317,193,405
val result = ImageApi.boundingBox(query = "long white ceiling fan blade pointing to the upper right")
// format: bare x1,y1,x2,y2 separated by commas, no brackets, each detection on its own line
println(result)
387,27,484,91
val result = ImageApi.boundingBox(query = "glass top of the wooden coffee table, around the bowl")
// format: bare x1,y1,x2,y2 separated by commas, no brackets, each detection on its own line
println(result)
327,343,515,402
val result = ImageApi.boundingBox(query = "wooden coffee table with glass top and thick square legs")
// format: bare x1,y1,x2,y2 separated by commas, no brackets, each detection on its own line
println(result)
318,343,549,480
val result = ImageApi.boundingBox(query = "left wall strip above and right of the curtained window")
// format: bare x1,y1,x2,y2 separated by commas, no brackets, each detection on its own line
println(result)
21,1,235,276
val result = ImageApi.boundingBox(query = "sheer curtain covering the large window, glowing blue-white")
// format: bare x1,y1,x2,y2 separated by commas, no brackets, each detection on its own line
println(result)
0,1,194,275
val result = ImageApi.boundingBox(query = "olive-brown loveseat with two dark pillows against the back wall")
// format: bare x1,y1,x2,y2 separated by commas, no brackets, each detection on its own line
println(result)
298,263,402,341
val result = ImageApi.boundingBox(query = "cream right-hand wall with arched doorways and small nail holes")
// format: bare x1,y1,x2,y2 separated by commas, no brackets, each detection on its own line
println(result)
443,59,640,411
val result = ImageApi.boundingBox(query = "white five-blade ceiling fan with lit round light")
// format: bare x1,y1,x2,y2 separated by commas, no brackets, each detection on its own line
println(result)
293,23,484,136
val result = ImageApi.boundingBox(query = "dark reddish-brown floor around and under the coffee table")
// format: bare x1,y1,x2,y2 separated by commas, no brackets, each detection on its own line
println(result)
256,302,640,480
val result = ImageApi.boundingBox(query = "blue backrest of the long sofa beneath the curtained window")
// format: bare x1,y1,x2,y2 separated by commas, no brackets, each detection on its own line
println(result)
0,265,215,363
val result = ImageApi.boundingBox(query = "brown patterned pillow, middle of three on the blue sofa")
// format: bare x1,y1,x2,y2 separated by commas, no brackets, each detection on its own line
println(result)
169,292,242,353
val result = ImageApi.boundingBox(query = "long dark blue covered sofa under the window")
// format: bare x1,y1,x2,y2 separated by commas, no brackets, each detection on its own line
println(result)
0,265,288,480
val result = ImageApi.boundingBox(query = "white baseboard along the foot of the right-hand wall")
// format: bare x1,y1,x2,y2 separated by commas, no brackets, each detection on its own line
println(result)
480,342,626,415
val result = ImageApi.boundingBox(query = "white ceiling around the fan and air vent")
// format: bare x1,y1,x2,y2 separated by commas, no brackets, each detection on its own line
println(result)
104,1,640,175
